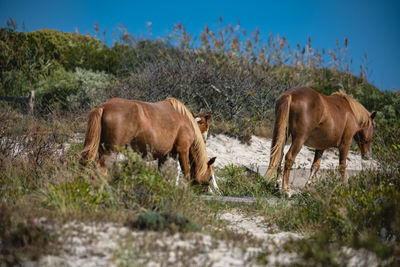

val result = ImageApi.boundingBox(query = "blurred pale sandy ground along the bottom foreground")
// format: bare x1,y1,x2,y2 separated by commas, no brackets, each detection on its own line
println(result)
29,210,378,267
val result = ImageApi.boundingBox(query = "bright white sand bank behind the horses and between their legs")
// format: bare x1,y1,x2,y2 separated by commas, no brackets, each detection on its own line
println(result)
207,134,377,193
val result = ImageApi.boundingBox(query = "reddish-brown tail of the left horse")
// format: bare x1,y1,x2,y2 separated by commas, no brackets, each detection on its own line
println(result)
80,107,103,166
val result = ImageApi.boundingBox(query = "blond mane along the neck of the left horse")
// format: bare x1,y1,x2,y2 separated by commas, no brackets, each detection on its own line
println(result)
166,97,208,175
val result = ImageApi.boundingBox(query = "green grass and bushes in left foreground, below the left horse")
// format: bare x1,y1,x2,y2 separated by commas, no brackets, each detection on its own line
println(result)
0,141,225,264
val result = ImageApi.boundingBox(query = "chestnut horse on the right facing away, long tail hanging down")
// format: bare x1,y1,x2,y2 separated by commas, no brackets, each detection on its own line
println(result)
264,87,376,196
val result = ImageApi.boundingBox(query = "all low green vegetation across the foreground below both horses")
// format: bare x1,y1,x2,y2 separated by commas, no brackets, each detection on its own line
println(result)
0,142,400,265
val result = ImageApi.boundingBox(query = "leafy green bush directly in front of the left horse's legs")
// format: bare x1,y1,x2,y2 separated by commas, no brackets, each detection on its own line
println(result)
110,148,214,227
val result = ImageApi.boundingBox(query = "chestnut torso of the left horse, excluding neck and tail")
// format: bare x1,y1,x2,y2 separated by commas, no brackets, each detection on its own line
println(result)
102,98,191,155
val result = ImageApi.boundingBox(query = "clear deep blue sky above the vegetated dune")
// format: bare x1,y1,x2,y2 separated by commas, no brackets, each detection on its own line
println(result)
0,0,400,89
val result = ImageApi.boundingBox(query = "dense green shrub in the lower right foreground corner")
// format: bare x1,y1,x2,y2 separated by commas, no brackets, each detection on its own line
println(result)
278,171,400,262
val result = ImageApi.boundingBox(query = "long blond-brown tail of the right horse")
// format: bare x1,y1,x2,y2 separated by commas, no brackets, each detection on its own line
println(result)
264,94,292,181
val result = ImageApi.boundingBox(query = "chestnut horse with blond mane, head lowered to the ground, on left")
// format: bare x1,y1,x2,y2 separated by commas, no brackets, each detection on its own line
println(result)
81,98,216,186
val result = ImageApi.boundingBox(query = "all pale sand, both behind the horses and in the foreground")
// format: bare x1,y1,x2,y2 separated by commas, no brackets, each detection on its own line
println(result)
13,135,377,267
